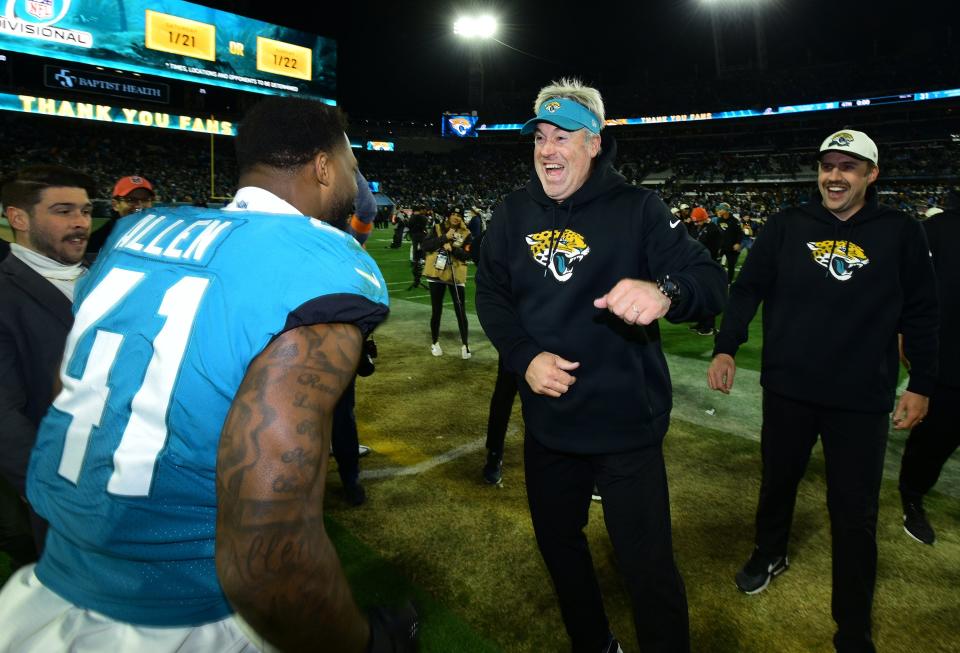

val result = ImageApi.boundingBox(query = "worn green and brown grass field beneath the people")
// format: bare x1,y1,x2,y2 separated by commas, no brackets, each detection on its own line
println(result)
0,230,960,653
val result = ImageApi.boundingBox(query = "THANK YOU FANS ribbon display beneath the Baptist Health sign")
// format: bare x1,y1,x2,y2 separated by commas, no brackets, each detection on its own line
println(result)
0,93,237,136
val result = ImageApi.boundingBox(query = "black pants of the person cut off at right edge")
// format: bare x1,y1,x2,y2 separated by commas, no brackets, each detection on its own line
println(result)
900,385,960,504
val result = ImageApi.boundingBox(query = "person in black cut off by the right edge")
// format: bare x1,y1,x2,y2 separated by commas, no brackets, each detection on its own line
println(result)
900,190,960,544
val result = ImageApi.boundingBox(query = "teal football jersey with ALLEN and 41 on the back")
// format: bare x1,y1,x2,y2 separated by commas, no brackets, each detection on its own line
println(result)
27,208,388,626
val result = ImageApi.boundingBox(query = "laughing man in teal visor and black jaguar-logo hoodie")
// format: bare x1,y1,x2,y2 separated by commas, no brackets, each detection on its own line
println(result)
476,80,726,653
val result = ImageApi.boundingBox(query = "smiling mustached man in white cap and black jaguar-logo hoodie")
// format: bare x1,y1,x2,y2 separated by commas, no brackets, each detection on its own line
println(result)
707,129,938,652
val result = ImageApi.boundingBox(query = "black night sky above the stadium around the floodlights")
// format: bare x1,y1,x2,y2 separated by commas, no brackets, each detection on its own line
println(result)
200,0,960,120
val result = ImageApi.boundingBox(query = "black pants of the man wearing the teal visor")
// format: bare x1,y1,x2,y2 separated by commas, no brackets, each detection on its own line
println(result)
524,433,690,653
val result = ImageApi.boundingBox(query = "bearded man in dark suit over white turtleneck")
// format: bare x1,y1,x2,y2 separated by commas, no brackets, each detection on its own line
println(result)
0,165,94,551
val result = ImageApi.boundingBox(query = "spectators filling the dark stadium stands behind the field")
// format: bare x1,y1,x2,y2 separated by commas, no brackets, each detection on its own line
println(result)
0,114,960,227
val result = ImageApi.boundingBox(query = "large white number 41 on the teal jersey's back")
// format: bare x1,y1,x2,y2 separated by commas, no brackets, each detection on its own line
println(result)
53,268,209,496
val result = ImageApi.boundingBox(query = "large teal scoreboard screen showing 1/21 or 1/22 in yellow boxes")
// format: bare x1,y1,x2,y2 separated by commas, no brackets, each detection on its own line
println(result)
0,0,337,104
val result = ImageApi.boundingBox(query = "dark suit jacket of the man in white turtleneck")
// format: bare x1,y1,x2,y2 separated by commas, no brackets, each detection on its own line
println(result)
0,254,73,496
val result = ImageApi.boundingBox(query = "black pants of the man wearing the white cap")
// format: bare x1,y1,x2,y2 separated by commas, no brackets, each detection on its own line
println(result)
756,391,889,653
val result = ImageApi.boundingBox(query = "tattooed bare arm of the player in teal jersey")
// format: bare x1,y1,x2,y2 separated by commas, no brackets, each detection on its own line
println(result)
216,324,369,652
